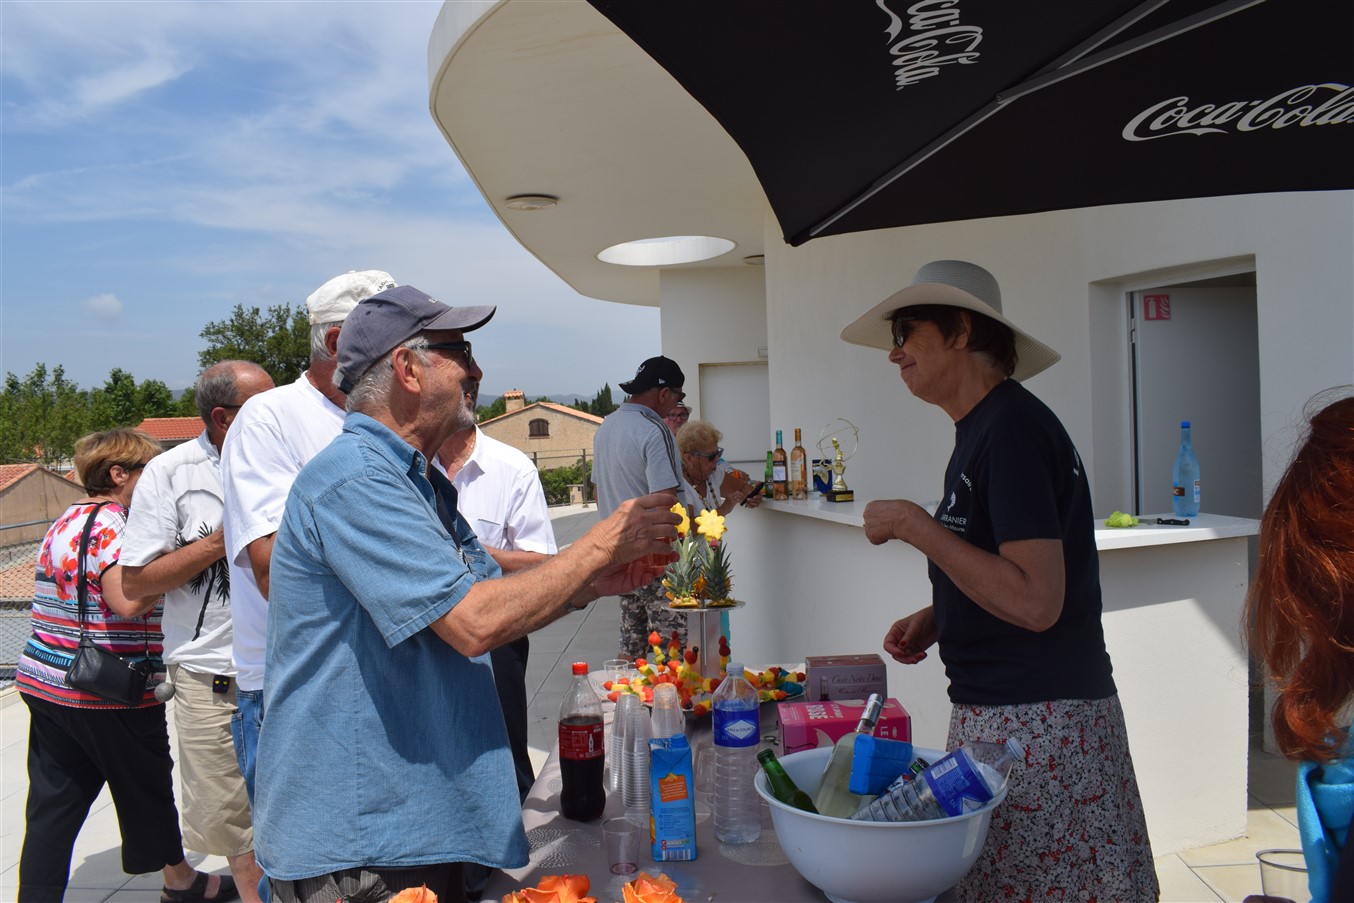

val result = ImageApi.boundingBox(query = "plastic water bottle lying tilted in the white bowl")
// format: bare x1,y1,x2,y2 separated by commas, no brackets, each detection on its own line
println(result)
852,738,1025,822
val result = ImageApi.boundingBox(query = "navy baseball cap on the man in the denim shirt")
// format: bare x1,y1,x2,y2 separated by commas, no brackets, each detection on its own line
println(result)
334,286,498,394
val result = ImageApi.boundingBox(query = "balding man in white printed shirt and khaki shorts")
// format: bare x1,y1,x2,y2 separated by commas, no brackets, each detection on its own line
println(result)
119,360,272,903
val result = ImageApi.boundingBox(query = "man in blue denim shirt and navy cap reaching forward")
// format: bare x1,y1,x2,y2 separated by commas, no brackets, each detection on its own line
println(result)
255,286,677,903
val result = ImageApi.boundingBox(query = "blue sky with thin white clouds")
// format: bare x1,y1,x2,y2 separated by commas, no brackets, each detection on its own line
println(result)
0,0,659,395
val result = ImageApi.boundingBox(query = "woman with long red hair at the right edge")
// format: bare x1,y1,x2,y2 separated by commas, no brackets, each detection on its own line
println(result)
1247,397,1354,903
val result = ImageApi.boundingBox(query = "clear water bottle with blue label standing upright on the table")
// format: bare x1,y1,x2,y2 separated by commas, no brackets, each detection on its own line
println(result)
712,662,761,843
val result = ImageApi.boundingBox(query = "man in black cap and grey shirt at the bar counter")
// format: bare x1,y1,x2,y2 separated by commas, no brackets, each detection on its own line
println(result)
593,356,686,658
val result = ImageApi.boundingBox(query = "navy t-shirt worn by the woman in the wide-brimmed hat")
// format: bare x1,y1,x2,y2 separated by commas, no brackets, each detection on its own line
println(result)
929,379,1116,705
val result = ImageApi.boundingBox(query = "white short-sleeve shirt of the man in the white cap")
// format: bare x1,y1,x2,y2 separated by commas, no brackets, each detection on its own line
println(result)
221,374,345,690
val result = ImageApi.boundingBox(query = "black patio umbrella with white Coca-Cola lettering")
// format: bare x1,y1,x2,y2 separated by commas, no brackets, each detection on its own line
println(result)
589,0,1354,245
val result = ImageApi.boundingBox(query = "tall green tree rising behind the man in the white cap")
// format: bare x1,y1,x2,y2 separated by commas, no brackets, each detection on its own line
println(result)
198,305,310,386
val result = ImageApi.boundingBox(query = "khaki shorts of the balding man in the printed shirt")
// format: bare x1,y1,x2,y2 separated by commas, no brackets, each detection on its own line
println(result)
169,665,253,856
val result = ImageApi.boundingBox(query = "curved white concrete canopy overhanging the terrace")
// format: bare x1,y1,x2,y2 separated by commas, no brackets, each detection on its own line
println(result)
428,0,768,306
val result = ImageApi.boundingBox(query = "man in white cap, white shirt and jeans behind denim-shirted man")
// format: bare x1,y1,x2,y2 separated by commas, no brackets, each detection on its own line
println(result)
221,269,395,800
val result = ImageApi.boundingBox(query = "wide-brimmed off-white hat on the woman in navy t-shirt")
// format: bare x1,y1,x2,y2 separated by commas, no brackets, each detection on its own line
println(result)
842,260,1062,380
